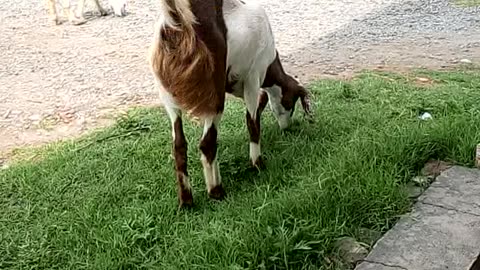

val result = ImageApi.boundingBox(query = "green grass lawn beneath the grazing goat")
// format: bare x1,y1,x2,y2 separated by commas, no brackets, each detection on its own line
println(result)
0,70,480,269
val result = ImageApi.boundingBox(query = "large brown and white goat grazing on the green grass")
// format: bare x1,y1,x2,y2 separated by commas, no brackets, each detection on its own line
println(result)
150,0,310,206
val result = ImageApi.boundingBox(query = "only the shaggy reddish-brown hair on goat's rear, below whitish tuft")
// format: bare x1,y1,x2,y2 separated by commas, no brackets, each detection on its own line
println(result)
152,25,219,117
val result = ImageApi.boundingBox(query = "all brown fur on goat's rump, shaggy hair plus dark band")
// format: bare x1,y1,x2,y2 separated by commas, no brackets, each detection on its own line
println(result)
150,0,226,117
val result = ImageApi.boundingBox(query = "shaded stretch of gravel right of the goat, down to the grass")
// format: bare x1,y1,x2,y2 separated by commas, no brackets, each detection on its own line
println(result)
285,0,480,79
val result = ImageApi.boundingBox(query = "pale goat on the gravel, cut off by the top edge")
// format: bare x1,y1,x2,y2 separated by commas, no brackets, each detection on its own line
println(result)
47,0,127,25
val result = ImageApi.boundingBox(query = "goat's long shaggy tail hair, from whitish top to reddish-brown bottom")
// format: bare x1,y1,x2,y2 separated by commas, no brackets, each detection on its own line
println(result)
150,0,219,116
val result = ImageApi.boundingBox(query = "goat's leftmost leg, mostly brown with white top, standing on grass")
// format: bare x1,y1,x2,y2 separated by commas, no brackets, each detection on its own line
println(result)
166,107,193,207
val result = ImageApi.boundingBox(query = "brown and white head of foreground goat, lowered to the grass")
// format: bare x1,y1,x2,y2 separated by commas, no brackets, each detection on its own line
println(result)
263,75,312,129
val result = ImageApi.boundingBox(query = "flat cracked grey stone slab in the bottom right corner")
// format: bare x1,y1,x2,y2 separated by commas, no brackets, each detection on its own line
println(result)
355,166,480,270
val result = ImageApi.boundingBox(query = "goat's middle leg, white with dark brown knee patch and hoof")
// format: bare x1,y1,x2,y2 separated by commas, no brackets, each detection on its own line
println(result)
200,114,225,200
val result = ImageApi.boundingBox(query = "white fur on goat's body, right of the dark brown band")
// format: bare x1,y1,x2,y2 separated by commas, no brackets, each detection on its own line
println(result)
224,0,276,96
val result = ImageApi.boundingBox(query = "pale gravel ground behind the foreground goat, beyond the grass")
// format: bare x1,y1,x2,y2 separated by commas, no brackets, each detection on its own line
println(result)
0,0,480,154
